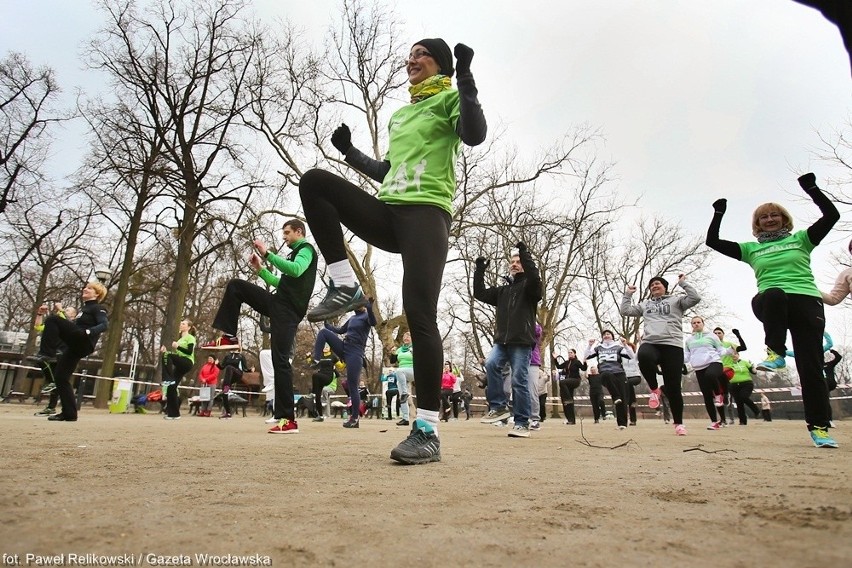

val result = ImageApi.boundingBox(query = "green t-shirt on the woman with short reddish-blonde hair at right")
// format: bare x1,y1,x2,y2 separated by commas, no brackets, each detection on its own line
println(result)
740,231,821,298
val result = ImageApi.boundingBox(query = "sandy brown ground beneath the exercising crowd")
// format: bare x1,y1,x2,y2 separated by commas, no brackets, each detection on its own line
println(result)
0,403,852,568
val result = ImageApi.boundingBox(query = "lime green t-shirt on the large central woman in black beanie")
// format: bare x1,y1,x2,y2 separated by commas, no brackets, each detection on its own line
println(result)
379,89,461,215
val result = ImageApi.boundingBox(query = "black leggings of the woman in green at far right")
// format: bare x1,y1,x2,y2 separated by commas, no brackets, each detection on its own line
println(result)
751,288,831,429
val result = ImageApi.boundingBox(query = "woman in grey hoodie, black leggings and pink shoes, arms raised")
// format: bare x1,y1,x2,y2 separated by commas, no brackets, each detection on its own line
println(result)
619,274,701,436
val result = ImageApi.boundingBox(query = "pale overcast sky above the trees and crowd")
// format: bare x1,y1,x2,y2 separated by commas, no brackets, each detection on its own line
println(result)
0,0,852,361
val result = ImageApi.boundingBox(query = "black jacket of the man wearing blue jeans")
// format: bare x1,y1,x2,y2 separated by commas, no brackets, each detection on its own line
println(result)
473,249,541,346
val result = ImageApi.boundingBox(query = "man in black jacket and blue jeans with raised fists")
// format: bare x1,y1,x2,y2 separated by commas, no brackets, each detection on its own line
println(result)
473,243,541,438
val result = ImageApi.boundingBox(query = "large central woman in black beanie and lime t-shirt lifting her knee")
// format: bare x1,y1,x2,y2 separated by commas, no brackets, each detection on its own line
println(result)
299,38,487,464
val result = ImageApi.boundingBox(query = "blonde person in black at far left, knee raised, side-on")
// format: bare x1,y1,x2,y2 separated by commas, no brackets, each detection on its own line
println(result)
31,282,109,422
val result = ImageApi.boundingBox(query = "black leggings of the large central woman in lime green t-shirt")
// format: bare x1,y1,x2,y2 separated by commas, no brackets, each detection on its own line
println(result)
299,169,450,412
